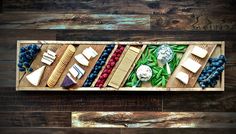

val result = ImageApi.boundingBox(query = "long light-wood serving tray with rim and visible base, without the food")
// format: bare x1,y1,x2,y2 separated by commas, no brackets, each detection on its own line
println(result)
16,40,225,91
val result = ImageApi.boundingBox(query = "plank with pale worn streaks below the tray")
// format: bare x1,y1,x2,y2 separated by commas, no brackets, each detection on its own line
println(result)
71,112,236,128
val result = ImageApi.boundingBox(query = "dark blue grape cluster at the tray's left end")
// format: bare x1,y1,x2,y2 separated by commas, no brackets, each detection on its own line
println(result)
18,44,40,72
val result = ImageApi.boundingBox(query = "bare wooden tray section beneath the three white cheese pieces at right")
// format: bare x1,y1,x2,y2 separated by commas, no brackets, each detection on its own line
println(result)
166,43,217,88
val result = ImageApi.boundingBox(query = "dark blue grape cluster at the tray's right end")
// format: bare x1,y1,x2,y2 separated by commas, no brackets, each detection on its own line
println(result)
198,55,226,89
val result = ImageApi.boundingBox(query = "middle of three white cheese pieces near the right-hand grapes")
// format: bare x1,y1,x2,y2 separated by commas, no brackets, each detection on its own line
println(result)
182,58,202,73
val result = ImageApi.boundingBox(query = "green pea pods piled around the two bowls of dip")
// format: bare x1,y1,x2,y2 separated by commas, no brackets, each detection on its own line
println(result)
125,45,187,87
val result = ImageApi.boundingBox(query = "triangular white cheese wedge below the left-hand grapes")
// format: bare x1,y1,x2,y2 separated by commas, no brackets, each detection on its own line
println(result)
26,66,45,86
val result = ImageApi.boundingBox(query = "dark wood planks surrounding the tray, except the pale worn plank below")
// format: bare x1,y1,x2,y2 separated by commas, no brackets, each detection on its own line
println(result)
0,0,236,134
